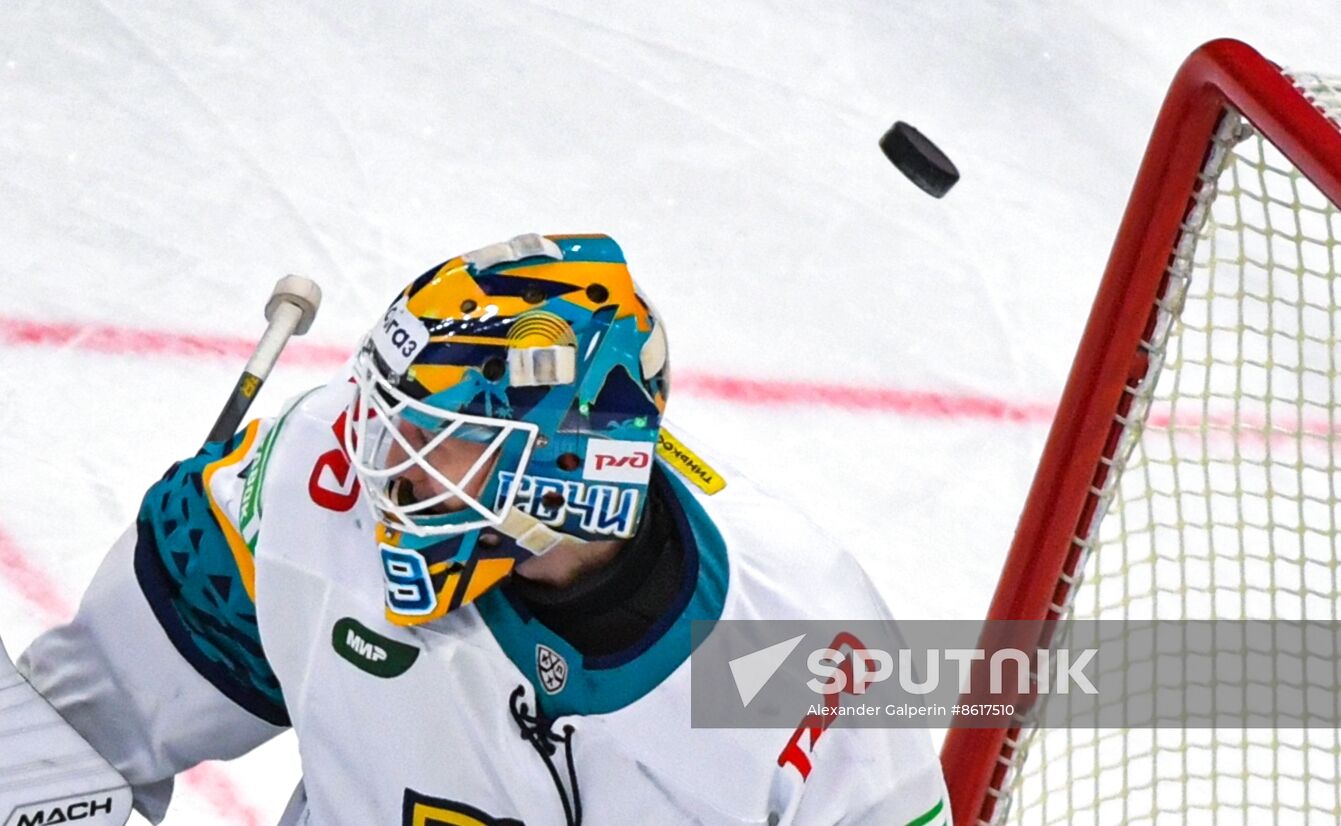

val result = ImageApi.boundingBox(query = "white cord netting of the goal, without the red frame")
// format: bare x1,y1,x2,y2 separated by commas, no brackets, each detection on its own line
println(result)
995,74,1341,825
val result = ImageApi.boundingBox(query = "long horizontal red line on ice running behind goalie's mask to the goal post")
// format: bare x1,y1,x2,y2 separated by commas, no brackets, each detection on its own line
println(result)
0,316,1053,424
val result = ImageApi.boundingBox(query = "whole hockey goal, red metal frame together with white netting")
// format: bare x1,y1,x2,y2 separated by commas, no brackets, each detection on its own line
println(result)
943,40,1341,826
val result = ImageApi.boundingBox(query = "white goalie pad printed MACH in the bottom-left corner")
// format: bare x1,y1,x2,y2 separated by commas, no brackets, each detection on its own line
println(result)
0,642,130,826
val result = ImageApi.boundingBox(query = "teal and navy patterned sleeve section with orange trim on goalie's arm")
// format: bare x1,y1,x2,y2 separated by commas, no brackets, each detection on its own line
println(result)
135,420,290,725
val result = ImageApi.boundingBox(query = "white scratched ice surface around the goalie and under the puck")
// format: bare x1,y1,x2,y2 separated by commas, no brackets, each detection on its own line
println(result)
0,0,1341,825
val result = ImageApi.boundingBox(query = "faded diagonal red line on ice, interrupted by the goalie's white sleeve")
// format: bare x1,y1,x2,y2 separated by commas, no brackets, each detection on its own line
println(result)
0,527,263,826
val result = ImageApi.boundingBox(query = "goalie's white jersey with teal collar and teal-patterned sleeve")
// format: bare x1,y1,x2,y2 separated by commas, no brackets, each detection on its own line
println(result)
20,381,949,826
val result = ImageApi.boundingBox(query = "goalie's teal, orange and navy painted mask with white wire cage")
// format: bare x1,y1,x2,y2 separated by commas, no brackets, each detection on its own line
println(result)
345,235,668,625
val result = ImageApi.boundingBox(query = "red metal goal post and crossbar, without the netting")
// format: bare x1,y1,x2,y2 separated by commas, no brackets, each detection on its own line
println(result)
941,40,1341,826
